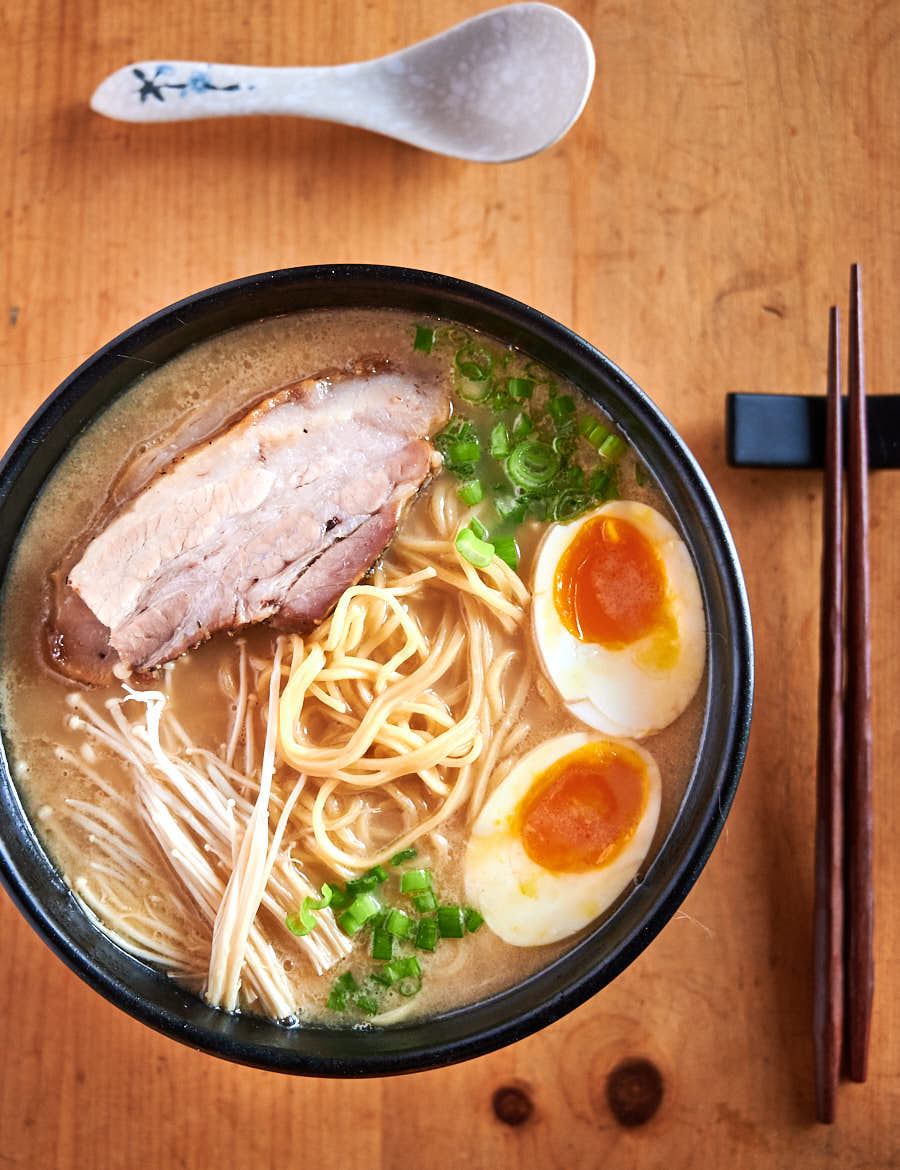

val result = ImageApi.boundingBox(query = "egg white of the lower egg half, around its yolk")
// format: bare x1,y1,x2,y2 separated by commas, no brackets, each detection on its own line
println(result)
463,731,661,947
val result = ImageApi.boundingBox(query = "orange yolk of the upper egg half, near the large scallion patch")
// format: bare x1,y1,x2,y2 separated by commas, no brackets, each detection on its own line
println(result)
554,516,668,649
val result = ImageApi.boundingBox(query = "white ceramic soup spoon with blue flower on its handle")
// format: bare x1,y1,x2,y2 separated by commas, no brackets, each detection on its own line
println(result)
90,4,593,163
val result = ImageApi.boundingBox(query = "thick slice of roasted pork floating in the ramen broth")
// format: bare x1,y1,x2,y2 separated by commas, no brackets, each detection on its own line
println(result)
63,364,449,673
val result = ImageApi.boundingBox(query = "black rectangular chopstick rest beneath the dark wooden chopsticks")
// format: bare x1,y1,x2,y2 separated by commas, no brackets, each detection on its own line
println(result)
726,394,900,472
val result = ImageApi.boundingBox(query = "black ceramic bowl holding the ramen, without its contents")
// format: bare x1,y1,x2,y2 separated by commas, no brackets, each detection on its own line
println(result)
0,264,753,1076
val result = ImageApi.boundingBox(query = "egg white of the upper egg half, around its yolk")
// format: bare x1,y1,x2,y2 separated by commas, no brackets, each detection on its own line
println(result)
531,500,706,739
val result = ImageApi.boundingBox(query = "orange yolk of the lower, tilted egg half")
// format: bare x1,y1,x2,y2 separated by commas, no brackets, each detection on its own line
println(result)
517,741,650,873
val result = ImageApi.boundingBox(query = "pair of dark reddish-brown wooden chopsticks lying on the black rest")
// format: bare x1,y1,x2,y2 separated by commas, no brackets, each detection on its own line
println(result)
813,264,874,1122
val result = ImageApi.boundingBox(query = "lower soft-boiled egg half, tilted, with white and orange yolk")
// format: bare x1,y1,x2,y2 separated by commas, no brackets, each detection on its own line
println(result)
465,731,660,947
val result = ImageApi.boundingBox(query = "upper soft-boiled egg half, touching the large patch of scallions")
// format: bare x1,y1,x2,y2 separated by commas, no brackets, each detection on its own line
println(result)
531,500,706,739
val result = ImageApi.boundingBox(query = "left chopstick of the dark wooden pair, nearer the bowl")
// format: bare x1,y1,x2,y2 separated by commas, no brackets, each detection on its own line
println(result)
812,307,844,1122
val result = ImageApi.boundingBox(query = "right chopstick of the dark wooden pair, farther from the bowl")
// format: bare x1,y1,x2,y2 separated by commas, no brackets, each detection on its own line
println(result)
845,264,874,1081
